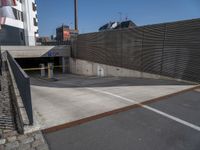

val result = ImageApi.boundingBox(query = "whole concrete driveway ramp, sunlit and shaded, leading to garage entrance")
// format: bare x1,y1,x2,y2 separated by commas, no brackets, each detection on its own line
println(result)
31,75,194,129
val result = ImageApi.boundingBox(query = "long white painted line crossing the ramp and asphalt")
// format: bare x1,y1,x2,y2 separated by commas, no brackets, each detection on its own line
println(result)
87,88,200,131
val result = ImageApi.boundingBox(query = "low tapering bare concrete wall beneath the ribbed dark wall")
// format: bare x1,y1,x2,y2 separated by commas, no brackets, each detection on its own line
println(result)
70,58,193,83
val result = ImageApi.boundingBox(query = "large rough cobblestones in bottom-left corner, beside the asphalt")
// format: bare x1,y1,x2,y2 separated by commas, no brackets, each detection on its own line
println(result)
0,131,49,150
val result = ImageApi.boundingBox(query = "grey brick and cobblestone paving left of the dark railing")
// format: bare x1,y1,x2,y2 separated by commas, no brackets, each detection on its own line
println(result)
0,56,49,150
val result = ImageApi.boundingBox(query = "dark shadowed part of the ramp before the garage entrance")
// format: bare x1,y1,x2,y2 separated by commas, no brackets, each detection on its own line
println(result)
30,74,194,88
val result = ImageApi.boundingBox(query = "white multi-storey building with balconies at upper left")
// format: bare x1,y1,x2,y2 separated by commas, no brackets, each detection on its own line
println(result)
0,0,39,46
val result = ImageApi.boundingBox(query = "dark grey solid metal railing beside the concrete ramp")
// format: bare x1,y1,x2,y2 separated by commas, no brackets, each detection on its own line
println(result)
7,52,33,124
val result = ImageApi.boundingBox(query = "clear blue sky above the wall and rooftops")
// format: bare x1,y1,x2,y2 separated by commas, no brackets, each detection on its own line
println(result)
37,0,200,36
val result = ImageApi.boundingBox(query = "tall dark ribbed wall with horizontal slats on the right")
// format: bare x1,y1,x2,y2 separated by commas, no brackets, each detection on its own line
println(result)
76,19,200,82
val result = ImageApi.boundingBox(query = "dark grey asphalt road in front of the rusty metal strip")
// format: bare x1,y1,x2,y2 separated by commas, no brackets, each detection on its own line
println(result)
44,88,200,150
